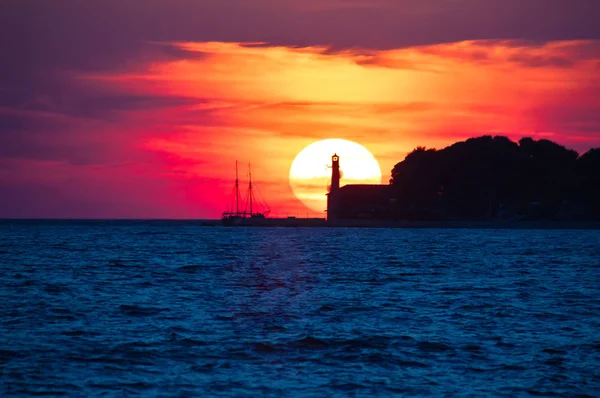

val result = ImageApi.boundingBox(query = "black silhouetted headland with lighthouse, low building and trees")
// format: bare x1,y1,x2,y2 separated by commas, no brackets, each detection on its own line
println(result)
328,136,600,227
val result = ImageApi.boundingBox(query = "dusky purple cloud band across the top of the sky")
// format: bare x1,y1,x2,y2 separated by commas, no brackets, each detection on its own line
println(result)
0,0,600,110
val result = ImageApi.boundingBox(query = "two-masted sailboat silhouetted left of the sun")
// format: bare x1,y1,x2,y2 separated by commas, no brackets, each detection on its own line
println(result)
221,161,270,225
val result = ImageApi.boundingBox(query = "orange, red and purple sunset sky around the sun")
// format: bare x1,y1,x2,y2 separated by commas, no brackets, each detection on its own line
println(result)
0,0,600,218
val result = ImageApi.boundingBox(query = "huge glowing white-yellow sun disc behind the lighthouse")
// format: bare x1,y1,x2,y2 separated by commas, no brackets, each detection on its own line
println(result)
290,139,381,212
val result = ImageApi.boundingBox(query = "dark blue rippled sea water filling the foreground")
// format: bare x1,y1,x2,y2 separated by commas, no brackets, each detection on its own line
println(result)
0,222,600,397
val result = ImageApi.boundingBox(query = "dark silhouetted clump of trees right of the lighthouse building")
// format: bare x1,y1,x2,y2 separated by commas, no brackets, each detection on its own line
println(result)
390,136,600,220
